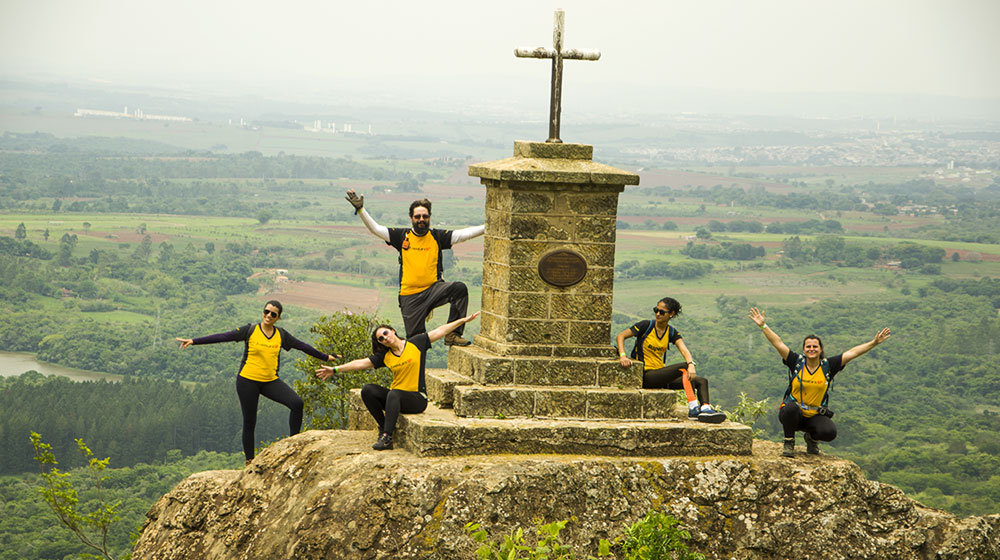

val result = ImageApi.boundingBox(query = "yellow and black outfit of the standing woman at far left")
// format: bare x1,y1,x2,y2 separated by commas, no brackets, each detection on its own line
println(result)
191,323,329,460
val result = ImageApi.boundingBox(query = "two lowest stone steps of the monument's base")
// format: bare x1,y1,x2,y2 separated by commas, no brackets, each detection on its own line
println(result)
348,376,753,457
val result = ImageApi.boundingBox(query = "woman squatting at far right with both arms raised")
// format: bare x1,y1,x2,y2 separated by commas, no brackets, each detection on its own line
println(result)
750,307,890,457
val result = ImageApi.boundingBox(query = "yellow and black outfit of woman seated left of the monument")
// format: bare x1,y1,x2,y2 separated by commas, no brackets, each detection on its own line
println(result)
361,333,431,436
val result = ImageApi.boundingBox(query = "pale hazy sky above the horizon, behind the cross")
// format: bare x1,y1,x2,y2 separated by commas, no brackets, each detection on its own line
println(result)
0,0,1000,109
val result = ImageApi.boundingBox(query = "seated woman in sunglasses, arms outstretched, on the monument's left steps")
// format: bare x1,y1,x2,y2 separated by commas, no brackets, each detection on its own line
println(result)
316,311,479,451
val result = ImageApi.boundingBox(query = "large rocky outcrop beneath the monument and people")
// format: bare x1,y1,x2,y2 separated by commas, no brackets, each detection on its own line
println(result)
133,431,1000,560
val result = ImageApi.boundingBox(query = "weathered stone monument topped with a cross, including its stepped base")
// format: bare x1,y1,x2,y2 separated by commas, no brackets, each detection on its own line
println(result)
351,11,752,456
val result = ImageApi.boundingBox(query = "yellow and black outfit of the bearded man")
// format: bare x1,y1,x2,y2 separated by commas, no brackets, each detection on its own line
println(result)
386,228,469,338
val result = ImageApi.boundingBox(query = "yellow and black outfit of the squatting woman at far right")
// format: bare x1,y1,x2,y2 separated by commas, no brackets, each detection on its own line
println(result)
778,352,843,441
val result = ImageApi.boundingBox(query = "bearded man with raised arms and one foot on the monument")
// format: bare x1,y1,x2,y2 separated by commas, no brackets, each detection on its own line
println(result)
347,190,486,346
